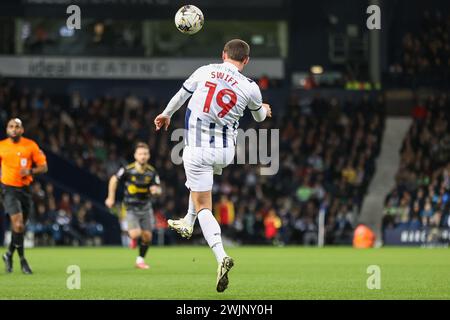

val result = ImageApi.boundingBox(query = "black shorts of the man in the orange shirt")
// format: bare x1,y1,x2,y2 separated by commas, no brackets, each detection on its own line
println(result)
1,184,33,221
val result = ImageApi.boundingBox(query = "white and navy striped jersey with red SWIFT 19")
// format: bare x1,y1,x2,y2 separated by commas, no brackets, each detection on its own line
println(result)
183,62,262,148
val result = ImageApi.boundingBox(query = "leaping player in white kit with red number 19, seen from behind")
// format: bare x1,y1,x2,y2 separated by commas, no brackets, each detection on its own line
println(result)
155,39,272,292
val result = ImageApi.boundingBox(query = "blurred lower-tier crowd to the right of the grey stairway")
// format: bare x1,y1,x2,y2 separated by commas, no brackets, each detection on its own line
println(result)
383,94,450,229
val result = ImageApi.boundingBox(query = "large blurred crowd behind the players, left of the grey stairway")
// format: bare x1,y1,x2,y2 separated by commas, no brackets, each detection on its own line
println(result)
0,83,385,244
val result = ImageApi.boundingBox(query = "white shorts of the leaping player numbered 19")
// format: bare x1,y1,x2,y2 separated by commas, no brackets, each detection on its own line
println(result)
183,146,235,192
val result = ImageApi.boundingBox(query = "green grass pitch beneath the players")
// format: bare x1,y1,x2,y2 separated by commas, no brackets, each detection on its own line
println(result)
0,246,450,300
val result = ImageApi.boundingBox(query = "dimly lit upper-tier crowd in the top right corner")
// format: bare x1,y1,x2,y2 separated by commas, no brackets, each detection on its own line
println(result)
390,11,450,86
